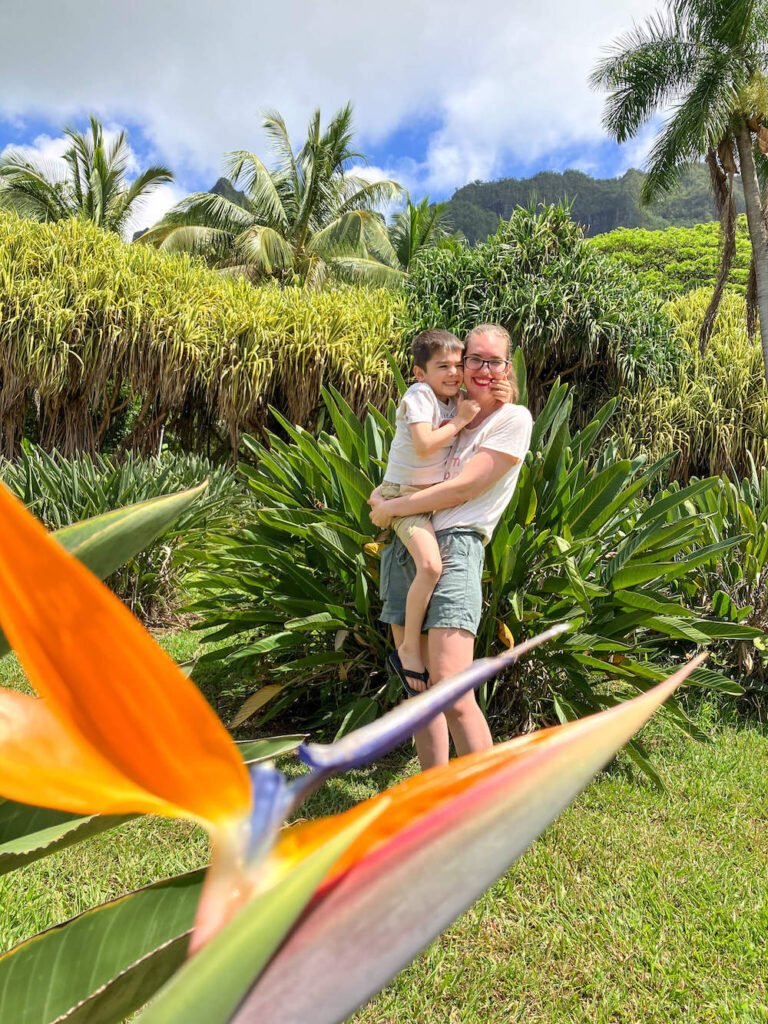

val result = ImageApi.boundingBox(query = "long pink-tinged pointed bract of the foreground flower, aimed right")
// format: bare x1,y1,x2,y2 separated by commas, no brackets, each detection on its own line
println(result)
231,655,705,1024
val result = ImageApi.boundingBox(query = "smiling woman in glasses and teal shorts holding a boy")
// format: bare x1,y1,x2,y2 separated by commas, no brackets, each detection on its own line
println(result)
369,324,532,769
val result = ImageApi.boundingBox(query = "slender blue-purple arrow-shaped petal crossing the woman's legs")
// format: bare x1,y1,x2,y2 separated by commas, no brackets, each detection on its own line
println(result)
298,624,570,776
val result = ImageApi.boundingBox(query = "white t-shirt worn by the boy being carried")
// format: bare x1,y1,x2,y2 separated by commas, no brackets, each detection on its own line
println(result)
384,383,458,486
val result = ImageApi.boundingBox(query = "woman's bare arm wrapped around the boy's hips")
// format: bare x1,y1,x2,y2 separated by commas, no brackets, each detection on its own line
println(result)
368,449,520,527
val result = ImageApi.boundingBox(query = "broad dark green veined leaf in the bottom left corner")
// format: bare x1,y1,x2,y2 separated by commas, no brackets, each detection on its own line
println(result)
0,870,204,1024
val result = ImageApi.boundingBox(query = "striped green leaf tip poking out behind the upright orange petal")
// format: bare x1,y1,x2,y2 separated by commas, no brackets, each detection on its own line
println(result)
0,481,208,656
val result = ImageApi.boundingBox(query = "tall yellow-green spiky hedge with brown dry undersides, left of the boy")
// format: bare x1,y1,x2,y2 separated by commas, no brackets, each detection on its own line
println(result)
0,214,409,456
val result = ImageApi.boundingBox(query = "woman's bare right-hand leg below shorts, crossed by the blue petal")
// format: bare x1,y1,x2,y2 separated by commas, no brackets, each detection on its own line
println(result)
430,629,494,768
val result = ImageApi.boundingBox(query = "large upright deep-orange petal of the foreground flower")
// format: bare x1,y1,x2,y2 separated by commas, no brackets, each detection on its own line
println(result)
0,486,251,822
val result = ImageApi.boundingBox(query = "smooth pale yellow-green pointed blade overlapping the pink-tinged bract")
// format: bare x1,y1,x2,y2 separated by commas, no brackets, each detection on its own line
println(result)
135,807,380,1024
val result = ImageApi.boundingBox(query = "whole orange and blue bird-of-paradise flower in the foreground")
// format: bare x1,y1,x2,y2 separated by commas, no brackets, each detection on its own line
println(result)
0,488,696,1024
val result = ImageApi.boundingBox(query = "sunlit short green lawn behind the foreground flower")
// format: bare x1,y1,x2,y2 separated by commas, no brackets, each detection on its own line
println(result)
0,633,768,1024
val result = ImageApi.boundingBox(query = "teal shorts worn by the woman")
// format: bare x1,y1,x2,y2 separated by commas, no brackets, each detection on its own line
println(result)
379,527,485,636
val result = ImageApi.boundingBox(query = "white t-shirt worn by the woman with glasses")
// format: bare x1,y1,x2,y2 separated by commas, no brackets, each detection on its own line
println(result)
432,406,534,544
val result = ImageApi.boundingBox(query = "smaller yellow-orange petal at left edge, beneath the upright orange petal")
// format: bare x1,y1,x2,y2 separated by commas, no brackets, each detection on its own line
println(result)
0,689,186,817
